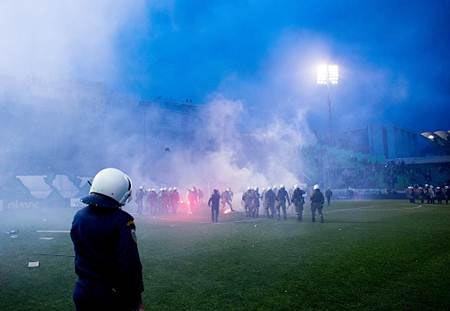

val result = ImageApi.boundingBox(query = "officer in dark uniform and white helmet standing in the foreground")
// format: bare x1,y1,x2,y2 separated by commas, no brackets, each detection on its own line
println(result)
70,168,144,311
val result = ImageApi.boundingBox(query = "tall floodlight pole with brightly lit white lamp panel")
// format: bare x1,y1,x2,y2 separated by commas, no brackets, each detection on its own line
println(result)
317,64,339,187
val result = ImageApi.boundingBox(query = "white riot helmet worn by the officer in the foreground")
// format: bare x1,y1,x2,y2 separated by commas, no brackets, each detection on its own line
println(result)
82,168,132,206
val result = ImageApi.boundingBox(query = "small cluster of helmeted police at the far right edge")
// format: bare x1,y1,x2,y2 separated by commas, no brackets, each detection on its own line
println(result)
406,184,450,204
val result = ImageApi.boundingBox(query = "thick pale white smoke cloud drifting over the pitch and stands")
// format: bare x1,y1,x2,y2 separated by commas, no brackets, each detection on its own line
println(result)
0,0,324,201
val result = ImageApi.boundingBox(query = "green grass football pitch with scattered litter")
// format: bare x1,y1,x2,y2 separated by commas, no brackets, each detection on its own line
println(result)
0,201,450,310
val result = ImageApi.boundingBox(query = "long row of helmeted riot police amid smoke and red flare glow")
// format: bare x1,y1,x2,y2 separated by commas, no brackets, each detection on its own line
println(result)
130,185,333,222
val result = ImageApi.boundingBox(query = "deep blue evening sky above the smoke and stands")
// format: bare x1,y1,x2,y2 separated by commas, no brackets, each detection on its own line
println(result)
110,0,450,130
